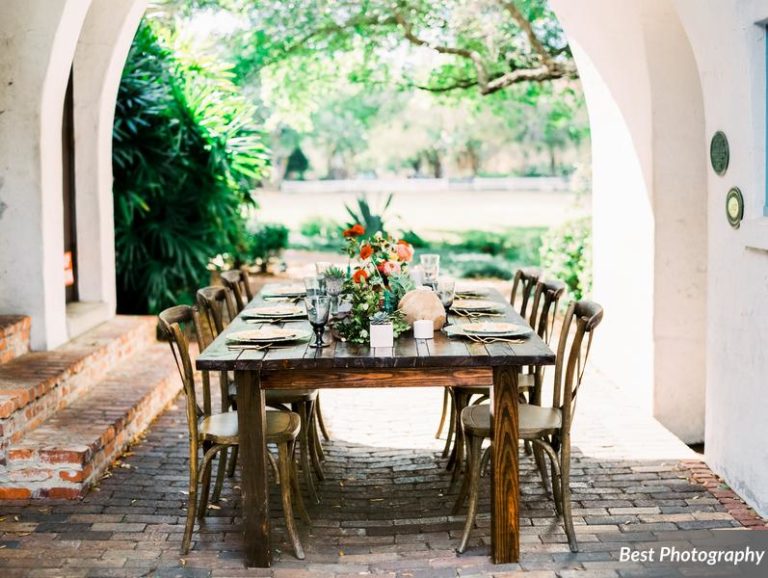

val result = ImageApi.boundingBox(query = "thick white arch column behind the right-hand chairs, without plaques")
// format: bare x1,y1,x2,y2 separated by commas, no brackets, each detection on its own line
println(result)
553,0,707,442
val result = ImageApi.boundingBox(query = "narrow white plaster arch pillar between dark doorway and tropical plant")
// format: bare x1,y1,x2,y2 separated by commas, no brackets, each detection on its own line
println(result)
74,0,147,316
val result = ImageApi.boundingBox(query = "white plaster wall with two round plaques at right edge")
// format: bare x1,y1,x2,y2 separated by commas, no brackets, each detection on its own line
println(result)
675,0,768,516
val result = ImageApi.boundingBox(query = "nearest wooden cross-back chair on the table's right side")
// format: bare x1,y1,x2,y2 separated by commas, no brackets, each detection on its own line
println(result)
453,301,603,553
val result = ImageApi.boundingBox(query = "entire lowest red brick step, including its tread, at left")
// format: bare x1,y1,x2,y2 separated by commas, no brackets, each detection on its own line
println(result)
0,343,181,499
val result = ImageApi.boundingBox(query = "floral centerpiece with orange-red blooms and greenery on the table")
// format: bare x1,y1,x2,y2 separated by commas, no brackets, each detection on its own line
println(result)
335,224,413,343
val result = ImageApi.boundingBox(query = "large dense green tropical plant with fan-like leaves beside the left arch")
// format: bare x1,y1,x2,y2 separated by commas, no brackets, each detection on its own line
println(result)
113,21,268,313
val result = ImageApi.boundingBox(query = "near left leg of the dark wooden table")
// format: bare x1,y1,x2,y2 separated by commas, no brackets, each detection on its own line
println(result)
235,371,272,568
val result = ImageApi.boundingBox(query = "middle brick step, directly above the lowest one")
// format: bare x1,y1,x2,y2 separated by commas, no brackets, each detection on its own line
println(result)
0,316,157,446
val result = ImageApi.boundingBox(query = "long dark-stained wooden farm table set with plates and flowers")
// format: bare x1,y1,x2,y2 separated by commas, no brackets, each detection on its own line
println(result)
197,290,555,567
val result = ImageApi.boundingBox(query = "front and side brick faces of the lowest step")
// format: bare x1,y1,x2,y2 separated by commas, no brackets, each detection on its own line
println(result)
0,344,181,499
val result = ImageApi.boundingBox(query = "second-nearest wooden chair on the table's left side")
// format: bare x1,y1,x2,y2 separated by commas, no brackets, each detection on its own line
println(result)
197,286,325,503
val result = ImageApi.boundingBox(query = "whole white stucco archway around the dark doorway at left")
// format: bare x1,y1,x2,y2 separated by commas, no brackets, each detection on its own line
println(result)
0,0,146,349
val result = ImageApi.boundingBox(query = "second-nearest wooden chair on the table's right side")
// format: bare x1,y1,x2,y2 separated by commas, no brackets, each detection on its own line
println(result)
448,280,566,485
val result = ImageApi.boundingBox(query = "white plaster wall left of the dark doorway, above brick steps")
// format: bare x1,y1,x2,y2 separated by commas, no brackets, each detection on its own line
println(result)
0,0,90,349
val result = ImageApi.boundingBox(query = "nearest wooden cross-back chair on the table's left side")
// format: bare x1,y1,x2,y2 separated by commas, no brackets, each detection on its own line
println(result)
159,305,309,560
